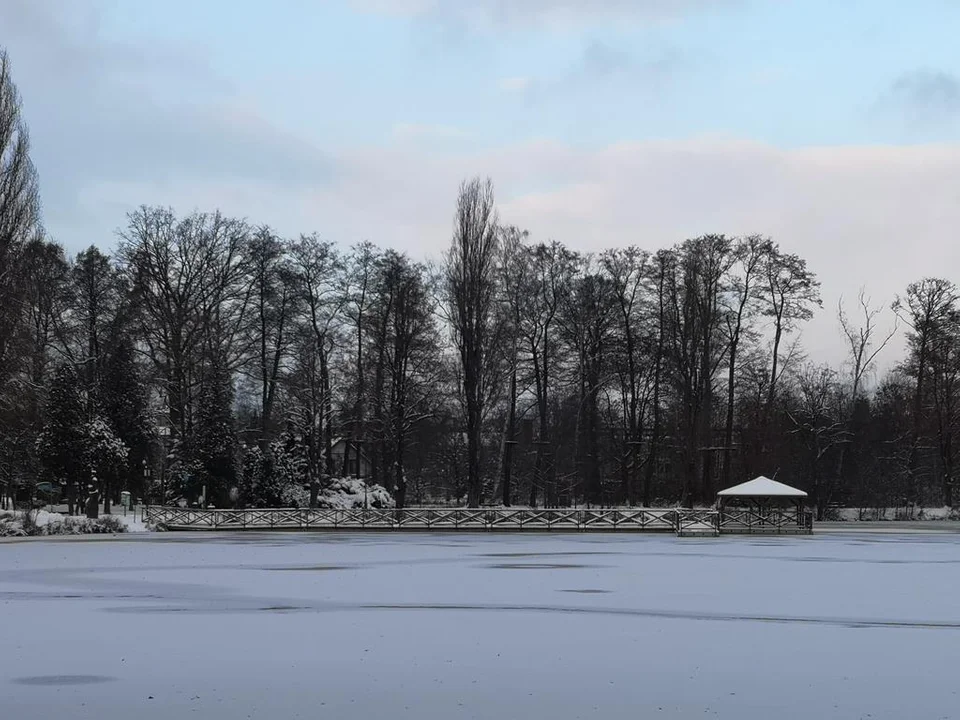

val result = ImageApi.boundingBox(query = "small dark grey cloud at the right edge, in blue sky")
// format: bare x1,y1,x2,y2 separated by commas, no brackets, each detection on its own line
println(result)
879,69,960,130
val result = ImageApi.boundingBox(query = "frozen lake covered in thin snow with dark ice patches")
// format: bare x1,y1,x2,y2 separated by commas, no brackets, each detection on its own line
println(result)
0,533,960,720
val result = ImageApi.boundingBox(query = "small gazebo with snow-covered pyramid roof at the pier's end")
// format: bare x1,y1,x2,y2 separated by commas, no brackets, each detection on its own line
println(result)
717,475,813,532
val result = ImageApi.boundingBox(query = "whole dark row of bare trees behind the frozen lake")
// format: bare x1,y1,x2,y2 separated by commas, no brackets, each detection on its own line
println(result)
0,49,960,516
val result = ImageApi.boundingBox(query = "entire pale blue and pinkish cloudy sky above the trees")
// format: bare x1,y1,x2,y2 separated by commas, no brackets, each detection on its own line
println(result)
0,0,960,364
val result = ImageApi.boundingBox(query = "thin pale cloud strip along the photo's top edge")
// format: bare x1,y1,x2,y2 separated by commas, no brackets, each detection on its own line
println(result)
354,0,740,28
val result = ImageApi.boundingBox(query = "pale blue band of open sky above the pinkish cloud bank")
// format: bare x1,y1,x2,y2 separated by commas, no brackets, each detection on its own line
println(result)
86,0,960,147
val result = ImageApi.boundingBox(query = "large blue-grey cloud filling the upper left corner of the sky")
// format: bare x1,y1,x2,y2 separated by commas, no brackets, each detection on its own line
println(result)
0,0,335,247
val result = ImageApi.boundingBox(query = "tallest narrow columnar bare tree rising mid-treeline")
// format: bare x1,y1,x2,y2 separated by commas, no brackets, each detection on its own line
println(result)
445,178,499,507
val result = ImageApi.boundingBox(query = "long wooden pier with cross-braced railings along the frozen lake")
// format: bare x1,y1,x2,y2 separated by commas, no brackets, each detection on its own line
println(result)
143,505,813,536
